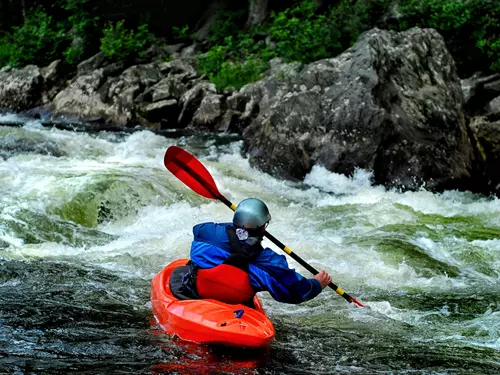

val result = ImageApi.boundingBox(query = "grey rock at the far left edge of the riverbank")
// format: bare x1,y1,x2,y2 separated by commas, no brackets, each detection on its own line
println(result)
0,65,43,111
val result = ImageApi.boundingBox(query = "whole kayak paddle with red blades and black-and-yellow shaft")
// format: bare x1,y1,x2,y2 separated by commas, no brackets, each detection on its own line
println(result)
164,146,364,307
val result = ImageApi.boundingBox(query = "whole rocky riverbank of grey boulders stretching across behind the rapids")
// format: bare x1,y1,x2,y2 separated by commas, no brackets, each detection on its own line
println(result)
0,28,500,194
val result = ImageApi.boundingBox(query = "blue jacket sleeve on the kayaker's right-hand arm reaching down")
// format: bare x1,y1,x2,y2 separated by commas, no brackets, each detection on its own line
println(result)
249,248,322,304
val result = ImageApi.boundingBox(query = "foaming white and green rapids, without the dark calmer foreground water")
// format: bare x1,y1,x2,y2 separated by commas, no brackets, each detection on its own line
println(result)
0,118,500,374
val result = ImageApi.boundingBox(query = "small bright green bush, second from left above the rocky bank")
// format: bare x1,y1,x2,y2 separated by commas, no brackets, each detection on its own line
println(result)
101,20,152,61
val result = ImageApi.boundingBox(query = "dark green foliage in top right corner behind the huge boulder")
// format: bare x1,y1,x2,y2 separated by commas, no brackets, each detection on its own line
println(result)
398,0,500,75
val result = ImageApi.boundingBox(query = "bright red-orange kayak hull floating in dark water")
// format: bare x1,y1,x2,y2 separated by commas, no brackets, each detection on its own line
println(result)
151,259,275,348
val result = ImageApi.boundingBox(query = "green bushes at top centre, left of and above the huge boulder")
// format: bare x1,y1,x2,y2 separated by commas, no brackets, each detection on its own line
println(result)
198,0,391,88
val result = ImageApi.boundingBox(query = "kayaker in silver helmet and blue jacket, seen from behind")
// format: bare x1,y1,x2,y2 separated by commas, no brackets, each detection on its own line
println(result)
176,198,331,304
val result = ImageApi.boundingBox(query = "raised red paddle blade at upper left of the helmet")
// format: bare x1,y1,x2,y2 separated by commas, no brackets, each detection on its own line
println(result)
163,146,221,199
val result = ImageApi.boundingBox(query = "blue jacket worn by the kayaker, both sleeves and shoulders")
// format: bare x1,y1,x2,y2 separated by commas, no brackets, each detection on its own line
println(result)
191,223,322,303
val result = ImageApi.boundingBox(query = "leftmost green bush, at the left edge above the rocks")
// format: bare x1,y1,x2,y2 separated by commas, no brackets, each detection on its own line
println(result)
0,9,67,67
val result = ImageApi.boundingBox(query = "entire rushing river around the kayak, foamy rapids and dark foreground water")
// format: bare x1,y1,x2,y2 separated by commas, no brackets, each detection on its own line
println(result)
0,114,500,375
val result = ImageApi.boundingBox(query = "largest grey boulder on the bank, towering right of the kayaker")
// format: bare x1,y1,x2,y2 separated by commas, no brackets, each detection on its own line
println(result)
241,28,473,189
